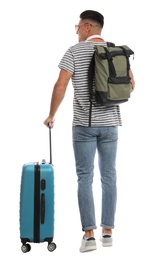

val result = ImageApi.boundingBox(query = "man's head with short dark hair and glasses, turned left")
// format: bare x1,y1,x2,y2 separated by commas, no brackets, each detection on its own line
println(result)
76,10,104,42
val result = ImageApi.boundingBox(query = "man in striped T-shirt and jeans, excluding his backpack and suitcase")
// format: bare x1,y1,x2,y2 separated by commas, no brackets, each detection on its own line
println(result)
44,10,135,252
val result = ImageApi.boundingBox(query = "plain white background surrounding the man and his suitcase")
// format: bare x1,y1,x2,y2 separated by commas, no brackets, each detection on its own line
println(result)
0,0,154,260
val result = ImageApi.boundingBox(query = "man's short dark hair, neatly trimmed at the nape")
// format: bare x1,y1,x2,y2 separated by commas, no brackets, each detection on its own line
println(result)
80,10,104,28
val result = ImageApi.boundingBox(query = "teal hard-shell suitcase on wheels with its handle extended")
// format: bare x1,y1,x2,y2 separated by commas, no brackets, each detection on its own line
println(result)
20,125,56,253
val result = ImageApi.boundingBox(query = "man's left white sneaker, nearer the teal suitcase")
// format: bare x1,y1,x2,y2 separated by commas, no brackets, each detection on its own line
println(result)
80,236,97,252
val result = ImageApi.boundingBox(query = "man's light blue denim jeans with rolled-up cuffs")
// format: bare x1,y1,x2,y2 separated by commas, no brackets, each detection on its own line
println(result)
72,126,118,231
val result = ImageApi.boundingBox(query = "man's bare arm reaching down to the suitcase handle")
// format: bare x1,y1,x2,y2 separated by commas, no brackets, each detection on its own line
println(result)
44,69,72,126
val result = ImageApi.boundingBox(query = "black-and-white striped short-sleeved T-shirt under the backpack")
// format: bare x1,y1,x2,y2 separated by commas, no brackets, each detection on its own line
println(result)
58,41,122,127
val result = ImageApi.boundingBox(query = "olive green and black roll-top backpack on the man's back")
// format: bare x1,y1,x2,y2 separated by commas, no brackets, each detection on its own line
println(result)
88,42,134,115
